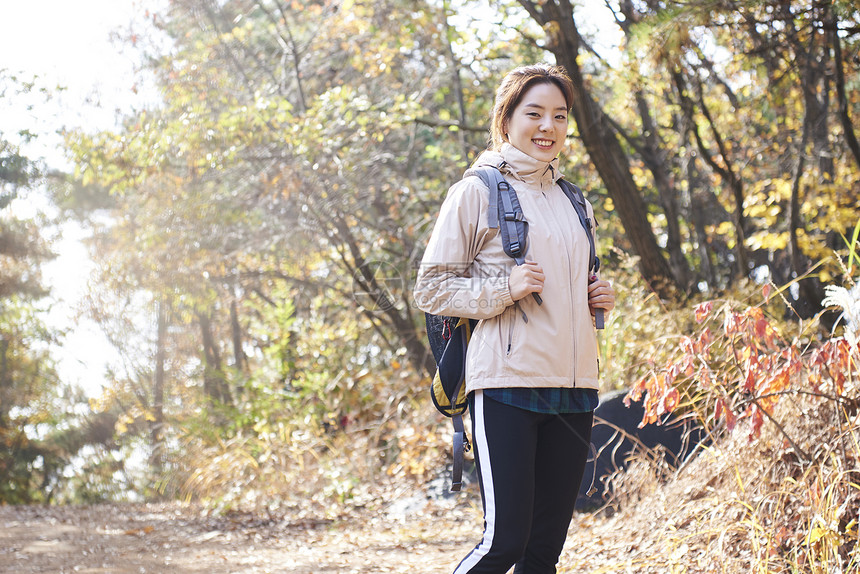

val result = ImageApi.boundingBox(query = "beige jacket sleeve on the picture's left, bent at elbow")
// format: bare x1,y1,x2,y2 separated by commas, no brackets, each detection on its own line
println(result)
413,176,513,319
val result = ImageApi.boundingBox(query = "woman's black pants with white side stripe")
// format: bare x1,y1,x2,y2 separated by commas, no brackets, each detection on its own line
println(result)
454,391,594,574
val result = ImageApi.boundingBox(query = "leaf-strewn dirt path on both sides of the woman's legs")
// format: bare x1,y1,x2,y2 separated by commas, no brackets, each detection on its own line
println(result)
0,495,692,574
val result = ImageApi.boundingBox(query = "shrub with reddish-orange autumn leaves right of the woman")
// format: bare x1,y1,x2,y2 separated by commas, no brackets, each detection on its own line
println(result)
626,285,860,454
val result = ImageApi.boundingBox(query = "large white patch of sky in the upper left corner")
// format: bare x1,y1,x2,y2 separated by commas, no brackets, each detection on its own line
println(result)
0,0,162,165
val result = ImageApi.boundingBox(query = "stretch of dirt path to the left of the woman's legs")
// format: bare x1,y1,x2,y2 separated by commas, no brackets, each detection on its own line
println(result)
0,504,479,574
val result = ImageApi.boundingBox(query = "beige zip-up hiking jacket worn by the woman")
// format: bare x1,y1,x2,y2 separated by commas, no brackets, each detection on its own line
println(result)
414,144,598,392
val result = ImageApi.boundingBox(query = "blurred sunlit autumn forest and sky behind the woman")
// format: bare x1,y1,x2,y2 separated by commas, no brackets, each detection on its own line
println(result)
0,0,860,513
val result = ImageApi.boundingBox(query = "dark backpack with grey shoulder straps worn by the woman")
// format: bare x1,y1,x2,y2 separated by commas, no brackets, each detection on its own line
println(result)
424,167,603,492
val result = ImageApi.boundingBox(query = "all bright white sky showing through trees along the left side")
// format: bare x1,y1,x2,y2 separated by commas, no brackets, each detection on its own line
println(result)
0,0,163,396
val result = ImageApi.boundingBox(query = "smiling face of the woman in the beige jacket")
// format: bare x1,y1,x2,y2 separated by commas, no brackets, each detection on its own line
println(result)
505,83,567,162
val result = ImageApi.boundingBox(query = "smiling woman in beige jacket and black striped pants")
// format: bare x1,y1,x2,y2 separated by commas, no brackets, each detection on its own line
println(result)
415,65,615,574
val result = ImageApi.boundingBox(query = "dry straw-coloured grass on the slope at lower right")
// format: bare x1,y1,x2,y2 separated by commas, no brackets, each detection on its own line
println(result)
559,382,860,574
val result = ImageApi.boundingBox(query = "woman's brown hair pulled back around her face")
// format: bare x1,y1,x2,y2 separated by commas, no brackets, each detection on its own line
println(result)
490,64,573,150
